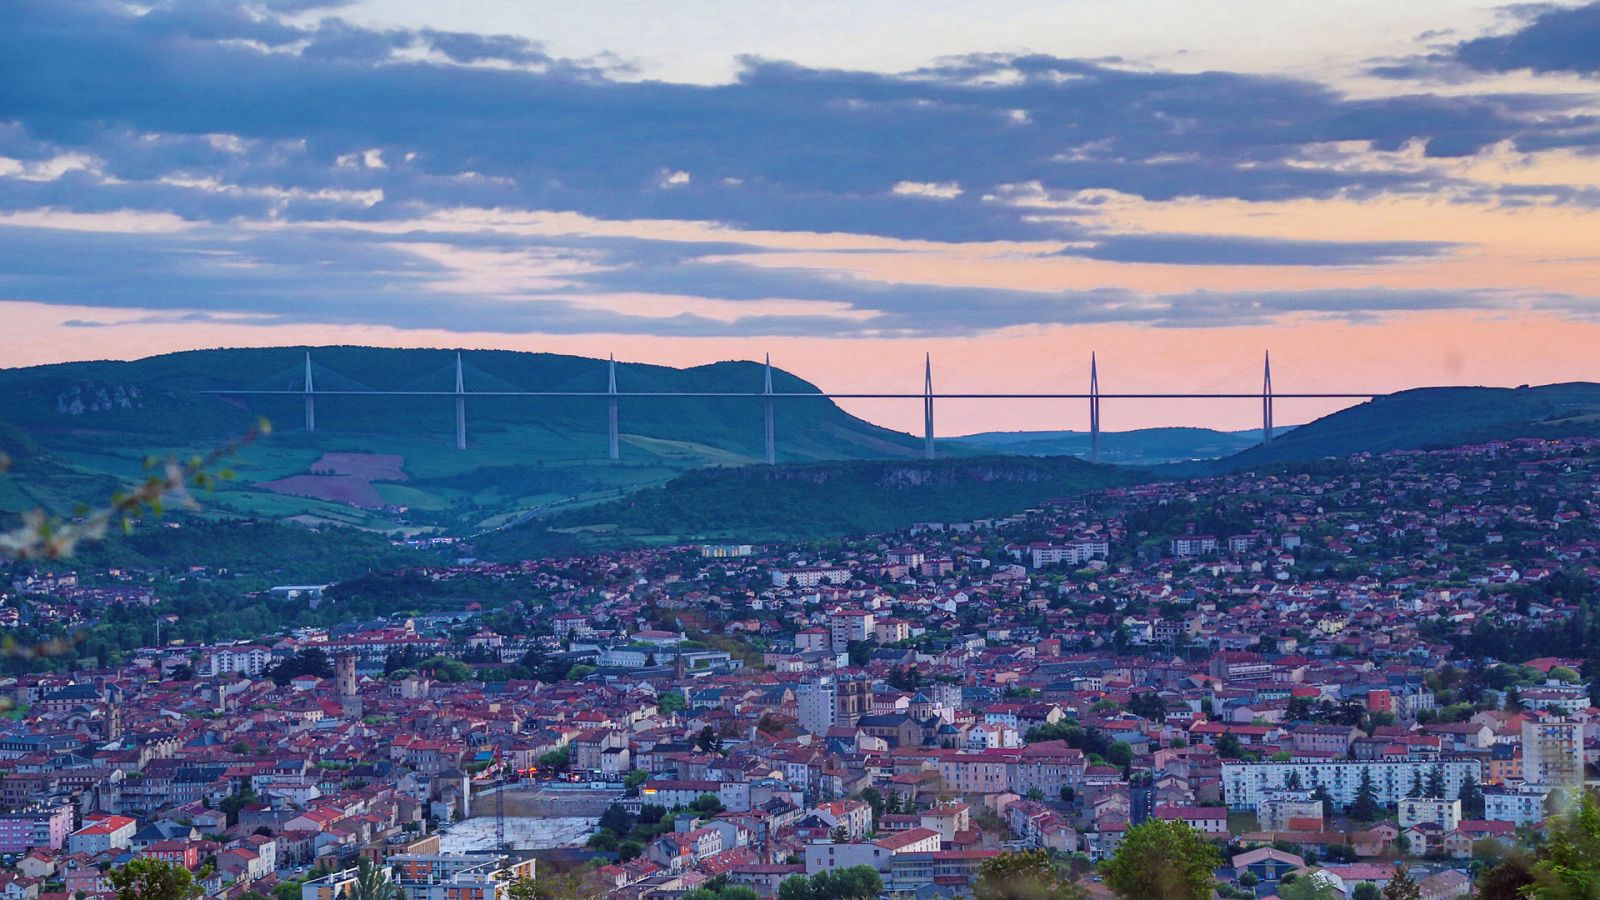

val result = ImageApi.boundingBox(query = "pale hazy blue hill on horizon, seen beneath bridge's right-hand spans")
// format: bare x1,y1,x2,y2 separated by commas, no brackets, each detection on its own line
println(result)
952,428,1261,466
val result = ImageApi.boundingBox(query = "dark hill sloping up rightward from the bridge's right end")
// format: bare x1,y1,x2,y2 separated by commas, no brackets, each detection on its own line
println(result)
1203,381,1600,472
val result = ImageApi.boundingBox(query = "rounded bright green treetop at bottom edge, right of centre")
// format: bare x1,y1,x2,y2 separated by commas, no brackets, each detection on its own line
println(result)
1099,818,1221,900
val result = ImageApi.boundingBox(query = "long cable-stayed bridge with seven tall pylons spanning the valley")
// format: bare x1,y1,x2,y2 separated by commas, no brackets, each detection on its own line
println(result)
200,351,1381,463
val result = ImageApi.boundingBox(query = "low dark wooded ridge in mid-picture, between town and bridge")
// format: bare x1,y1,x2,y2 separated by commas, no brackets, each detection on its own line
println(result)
474,456,1146,559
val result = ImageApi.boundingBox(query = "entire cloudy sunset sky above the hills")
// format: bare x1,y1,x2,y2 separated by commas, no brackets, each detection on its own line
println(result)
0,0,1600,434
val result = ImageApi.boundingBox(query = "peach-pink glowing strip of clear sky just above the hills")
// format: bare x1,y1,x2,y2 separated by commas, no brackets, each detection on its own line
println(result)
0,303,1600,436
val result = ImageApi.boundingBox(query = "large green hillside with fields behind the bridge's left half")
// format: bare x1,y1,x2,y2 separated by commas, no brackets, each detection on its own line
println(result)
0,346,922,532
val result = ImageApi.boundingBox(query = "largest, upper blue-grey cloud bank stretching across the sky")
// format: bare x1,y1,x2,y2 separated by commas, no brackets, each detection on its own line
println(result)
0,0,1600,240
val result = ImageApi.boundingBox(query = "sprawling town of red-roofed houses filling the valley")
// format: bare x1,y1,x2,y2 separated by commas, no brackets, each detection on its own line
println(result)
0,439,1600,900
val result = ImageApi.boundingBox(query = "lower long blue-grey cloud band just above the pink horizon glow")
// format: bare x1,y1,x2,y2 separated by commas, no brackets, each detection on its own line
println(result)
0,227,1548,336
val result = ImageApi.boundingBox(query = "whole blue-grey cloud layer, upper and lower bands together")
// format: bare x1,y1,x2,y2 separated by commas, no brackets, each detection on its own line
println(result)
0,0,1600,336
